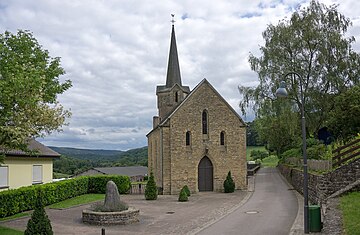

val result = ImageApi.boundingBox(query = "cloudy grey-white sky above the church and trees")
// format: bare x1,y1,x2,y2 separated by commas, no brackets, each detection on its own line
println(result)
0,0,360,150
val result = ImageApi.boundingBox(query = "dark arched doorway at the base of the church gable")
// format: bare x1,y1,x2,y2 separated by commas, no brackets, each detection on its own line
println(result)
198,156,214,192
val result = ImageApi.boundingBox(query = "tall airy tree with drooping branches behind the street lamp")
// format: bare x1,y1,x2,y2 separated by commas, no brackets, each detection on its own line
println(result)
239,1,360,151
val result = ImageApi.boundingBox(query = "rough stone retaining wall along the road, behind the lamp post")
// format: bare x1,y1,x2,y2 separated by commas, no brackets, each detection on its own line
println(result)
278,158,360,204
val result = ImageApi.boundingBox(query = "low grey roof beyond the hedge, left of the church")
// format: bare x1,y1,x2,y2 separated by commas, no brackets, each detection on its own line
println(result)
93,166,148,176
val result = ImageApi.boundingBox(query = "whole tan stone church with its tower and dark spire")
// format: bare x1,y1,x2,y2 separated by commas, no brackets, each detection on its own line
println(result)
147,20,247,194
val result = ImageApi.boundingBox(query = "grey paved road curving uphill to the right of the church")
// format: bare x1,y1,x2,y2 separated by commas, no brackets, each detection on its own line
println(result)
198,168,298,235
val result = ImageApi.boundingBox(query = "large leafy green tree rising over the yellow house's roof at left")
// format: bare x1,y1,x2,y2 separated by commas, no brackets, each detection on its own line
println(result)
0,30,71,161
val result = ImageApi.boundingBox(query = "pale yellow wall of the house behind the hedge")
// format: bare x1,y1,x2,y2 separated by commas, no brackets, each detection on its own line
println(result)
0,157,53,191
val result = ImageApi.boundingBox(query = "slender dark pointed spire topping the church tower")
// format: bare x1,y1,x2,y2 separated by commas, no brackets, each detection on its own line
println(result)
166,14,182,88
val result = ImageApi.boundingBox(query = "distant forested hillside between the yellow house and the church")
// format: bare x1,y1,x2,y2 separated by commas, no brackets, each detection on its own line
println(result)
50,147,147,175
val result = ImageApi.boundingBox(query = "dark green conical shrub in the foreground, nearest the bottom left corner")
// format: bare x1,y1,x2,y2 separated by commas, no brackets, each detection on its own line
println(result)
24,190,54,235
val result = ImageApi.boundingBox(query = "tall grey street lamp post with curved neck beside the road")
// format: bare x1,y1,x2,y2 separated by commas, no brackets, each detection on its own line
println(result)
276,72,309,233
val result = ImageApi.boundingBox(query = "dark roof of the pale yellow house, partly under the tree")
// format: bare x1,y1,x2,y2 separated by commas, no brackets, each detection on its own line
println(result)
0,139,60,157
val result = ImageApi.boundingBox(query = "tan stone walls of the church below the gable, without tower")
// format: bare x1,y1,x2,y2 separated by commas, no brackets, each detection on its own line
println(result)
148,80,246,194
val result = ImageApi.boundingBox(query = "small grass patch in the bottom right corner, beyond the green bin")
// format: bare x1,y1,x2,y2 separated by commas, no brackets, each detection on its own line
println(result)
340,192,360,235
